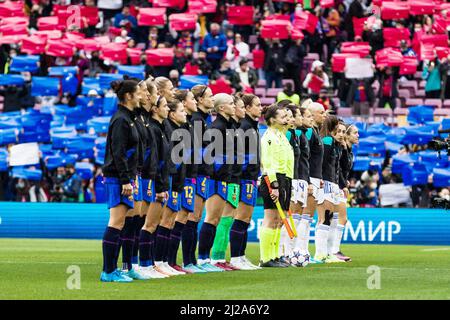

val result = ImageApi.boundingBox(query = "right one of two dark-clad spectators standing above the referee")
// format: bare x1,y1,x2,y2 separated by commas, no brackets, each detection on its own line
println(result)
285,39,306,94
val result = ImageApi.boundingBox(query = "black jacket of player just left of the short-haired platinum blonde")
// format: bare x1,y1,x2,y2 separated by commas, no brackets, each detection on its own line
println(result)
191,109,213,177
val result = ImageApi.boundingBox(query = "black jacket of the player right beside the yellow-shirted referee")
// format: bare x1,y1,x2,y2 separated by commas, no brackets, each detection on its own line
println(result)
239,115,261,180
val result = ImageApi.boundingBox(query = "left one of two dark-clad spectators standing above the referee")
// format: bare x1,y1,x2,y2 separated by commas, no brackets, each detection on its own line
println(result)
260,39,286,89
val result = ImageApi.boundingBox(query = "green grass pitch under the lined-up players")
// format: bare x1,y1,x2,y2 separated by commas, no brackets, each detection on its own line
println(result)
0,239,450,300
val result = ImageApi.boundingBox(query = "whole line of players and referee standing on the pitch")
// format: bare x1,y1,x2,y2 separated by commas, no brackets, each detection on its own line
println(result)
100,77,358,282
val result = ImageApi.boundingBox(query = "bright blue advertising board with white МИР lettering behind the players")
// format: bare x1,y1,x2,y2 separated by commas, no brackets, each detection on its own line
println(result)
0,202,450,245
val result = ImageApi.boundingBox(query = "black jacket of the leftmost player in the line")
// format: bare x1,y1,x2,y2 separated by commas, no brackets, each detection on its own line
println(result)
103,105,141,184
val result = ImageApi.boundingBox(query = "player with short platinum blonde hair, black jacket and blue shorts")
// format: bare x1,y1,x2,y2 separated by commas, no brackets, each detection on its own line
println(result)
198,93,236,272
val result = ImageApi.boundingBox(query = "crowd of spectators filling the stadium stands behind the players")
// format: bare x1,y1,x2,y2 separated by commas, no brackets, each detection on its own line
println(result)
0,0,450,207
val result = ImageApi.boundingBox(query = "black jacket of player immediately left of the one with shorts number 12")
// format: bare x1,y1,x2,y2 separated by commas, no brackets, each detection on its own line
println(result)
164,120,186,192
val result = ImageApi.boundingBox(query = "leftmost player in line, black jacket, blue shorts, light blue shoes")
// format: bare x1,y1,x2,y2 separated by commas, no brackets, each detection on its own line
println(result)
100,80,140,282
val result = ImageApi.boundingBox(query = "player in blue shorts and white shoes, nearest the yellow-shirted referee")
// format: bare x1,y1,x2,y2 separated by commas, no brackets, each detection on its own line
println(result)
230,94,262,270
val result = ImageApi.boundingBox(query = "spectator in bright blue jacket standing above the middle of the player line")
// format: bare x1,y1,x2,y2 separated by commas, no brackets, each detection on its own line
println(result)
203,23,227,70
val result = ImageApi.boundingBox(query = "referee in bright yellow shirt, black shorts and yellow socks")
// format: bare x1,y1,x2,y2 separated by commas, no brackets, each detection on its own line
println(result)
259,104,294,267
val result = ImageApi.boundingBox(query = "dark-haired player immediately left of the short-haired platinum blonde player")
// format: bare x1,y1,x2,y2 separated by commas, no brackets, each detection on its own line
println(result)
181,85,215,272
